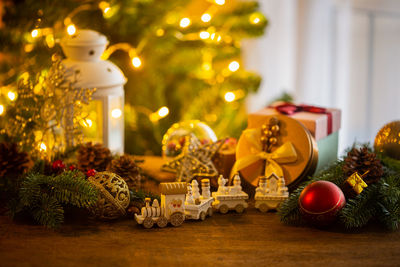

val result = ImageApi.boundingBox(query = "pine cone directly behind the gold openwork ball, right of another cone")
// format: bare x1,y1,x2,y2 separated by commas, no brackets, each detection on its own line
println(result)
111,155,142,189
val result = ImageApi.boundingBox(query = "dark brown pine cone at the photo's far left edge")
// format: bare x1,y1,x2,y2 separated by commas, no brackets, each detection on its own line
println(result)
0,142,31,179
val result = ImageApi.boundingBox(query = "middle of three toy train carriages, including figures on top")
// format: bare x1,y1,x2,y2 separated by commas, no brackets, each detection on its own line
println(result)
212,175,249,214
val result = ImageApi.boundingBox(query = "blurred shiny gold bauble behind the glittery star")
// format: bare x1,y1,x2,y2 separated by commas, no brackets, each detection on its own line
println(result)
162,120,217,157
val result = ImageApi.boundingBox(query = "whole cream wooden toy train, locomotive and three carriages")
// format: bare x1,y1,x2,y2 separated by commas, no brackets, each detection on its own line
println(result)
135,174,288,228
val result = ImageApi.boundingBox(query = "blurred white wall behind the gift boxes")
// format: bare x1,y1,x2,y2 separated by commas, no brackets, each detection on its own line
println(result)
244,0,400,153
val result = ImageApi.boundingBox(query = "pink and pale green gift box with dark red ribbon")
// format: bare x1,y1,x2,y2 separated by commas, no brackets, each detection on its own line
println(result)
248,102,341,173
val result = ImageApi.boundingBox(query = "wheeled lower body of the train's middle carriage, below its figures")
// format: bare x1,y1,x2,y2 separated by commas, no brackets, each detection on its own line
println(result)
213,192,249,214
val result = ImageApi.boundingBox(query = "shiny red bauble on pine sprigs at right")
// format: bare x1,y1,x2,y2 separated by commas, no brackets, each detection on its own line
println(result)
299,181,346,226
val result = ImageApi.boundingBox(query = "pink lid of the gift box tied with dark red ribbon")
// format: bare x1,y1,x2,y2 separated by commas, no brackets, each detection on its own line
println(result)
248,103,341,142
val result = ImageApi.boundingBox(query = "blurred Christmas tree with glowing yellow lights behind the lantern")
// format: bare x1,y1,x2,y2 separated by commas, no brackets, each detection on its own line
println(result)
0,0,267,154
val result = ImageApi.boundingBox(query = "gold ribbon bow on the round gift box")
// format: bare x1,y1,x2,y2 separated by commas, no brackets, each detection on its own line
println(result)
230,128,297,180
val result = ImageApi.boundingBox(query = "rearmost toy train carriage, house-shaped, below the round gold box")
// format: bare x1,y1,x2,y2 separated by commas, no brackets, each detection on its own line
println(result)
254,173,289,212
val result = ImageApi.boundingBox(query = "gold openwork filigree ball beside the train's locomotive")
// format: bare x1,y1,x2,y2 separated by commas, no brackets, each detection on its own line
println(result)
88,172,130,220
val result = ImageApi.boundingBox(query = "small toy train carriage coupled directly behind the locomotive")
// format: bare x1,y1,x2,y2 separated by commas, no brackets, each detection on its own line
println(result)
185,179,214,221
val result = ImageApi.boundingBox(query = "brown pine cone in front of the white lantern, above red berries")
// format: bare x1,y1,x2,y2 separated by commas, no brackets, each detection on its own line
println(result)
78,142,112,172
